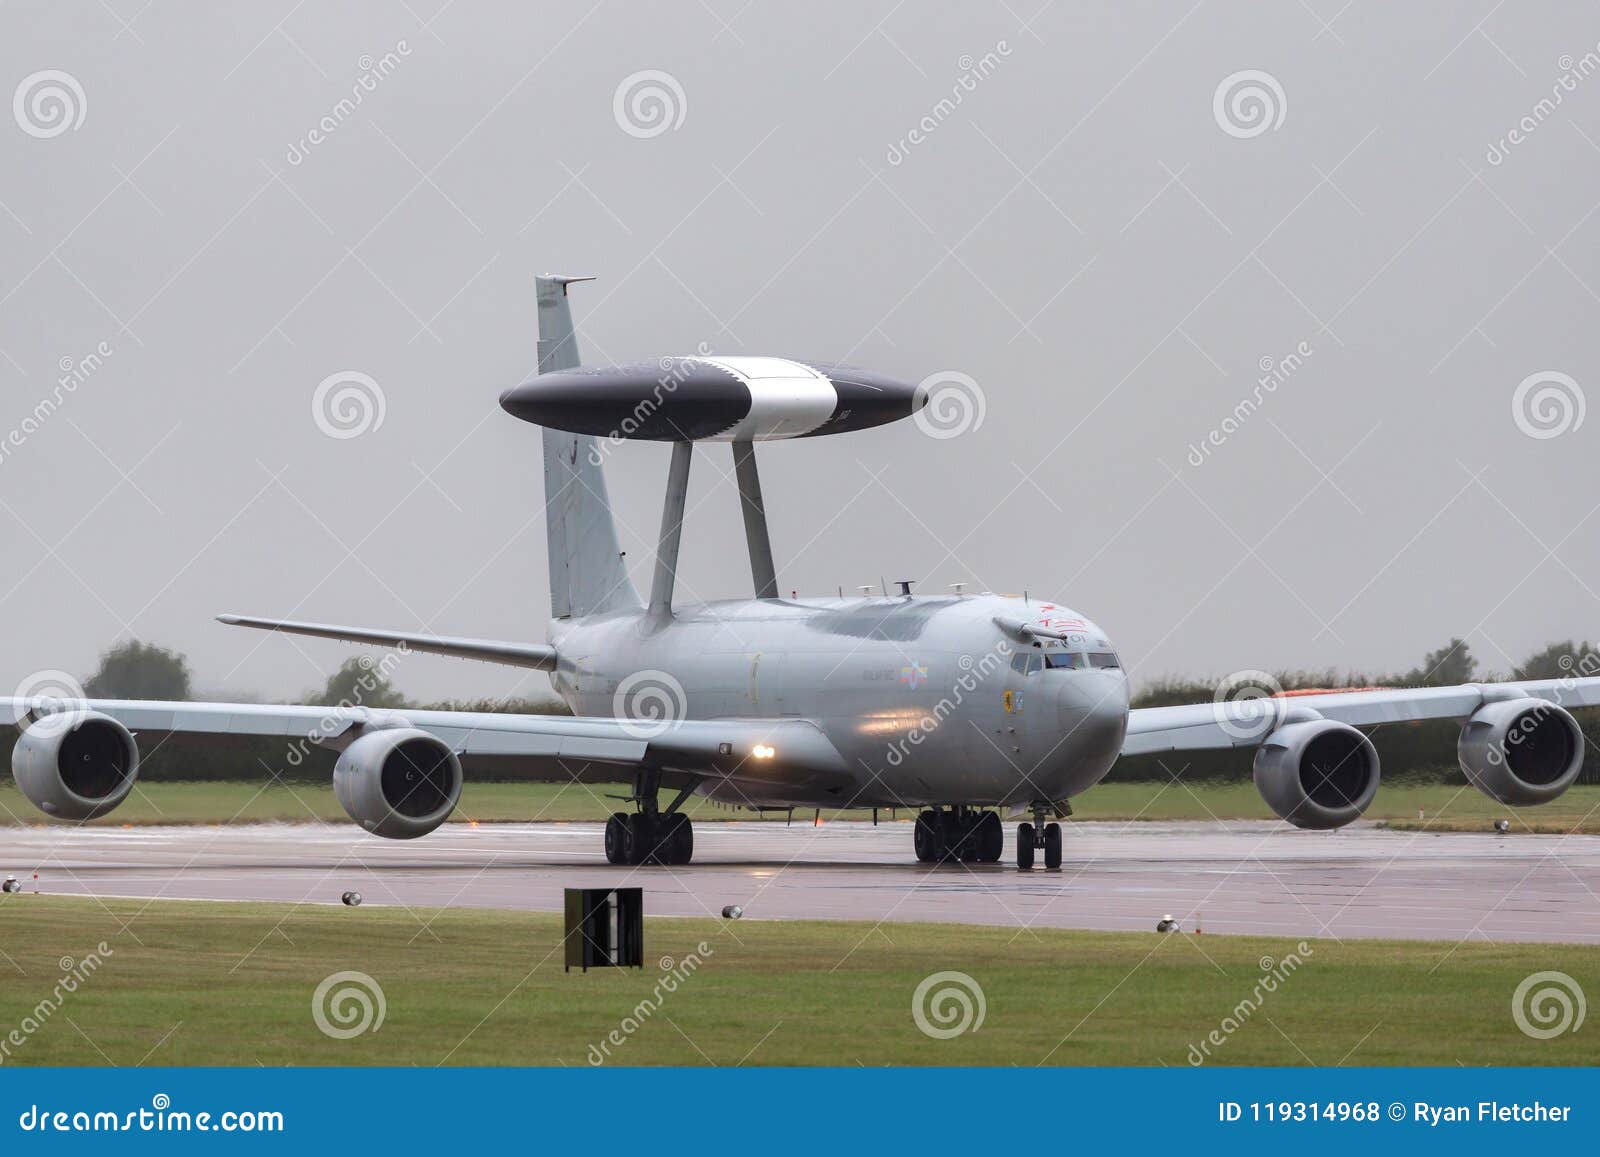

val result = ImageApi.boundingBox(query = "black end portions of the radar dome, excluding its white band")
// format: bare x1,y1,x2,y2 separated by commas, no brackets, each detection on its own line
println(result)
501,357,923,442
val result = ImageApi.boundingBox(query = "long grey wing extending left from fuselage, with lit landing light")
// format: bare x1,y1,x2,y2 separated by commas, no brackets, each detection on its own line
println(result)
0,698,846,783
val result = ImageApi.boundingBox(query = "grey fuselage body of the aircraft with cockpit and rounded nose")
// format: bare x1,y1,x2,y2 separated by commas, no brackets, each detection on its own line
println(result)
550,594,1128,808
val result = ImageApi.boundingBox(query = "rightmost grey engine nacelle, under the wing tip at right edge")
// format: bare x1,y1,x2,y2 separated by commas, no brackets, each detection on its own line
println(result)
1456,699,1584,808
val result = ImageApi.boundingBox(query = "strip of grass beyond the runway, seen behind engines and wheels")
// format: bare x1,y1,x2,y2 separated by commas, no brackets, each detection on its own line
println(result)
0,781,1600,832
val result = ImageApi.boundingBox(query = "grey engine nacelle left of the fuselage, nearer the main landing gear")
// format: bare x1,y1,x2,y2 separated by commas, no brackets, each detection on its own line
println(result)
333,727,461,840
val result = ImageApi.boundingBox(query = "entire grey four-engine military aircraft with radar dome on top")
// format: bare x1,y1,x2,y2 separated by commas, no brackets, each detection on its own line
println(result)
0,277,1600,869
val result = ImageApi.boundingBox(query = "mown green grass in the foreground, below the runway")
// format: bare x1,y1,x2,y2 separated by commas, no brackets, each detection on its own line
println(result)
0,895,1600,1066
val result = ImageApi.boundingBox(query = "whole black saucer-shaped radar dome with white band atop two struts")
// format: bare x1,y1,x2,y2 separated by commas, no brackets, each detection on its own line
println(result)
501,357,926,442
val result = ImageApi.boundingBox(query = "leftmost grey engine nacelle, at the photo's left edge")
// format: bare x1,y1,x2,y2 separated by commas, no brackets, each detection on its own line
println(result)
11,711,139,819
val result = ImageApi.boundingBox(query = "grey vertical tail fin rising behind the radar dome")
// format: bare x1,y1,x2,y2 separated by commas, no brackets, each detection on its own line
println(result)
538,277,643,618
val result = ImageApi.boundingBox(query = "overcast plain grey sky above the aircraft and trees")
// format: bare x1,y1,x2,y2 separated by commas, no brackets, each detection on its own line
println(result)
0,0,1600,698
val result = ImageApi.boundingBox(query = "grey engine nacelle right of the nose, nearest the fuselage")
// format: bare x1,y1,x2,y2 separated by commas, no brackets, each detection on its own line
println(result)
1254,719,1378,831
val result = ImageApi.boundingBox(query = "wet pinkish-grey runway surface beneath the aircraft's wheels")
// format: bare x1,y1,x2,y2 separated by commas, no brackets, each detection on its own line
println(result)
0,821,1600,943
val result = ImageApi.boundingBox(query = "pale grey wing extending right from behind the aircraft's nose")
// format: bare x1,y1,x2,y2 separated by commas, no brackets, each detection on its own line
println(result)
1122,679,1600,755
